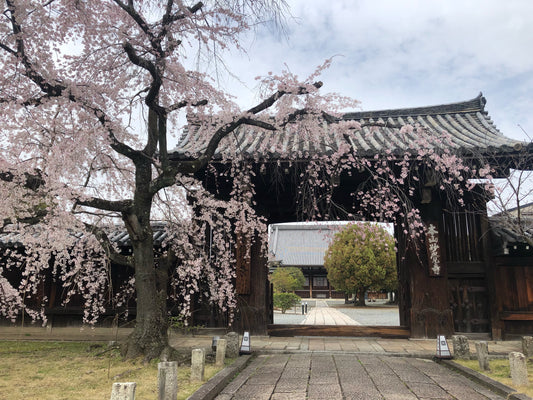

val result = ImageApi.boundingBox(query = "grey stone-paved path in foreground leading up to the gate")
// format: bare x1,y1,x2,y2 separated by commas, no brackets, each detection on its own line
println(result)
215,353,504,400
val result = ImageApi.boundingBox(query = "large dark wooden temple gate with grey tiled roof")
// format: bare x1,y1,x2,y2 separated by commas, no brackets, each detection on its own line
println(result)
174,94,522,338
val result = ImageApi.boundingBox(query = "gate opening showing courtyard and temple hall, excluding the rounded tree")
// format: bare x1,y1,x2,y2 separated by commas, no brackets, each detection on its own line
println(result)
269,221,408,337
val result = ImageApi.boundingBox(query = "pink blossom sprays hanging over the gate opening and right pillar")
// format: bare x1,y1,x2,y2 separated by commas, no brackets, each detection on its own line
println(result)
274,119,491,253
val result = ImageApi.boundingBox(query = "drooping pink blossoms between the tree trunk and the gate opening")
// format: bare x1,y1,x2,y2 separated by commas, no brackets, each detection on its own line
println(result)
156,176,266,320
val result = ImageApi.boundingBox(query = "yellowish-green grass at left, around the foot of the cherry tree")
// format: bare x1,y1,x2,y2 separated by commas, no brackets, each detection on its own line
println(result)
0,341,227,400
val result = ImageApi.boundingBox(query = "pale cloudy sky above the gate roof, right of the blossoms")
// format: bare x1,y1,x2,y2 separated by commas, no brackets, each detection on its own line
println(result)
221,0,533,140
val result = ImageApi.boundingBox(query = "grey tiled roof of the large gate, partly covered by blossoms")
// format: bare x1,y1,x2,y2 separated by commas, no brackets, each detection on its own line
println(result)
172,93,520,159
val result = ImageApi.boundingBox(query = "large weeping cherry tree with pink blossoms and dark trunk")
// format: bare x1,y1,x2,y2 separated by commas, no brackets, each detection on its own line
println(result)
0,0,490,359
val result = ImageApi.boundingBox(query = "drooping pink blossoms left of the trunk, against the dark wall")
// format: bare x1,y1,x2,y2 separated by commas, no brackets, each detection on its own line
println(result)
0,214,113,324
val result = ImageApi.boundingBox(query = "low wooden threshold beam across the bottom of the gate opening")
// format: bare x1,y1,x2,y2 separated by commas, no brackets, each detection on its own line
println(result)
268,324,411,339
